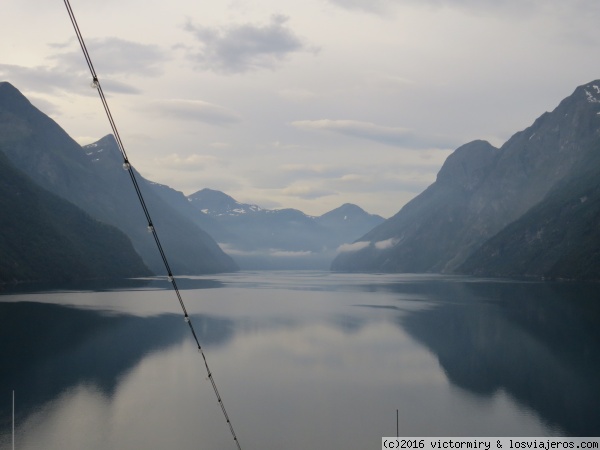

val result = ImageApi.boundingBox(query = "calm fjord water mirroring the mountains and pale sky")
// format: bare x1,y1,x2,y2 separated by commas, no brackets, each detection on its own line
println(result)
0,272,600,450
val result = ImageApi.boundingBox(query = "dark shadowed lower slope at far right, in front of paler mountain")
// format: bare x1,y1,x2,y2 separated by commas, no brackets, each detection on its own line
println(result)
457,140,600,280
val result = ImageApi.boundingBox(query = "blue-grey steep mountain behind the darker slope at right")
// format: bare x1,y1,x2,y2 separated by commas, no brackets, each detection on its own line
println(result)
332,81,600,278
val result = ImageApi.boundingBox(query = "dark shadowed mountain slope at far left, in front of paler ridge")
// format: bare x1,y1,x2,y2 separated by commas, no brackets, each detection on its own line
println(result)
0,147,151,283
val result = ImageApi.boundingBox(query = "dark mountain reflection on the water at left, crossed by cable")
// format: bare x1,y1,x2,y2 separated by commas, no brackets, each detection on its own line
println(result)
0,302,233,427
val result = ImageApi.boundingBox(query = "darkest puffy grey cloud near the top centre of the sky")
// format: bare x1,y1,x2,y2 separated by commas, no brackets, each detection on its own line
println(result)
185,15,305,73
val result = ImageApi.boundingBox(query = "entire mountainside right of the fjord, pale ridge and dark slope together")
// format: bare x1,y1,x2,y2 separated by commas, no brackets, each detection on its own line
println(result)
331,81,600,278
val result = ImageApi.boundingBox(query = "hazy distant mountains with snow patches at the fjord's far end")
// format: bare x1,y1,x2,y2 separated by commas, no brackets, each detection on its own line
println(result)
180,187,384,269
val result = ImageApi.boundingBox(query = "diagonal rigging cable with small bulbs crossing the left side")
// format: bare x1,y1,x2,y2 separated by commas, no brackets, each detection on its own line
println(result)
64,0,241,450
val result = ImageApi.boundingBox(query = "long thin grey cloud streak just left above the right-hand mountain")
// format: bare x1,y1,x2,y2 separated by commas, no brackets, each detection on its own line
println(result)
292,119,457,149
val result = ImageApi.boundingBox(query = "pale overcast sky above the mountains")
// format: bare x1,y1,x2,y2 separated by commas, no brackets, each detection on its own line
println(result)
0,0,600,217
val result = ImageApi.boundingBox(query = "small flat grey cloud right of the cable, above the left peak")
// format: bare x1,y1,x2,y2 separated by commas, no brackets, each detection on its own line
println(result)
150,99,241,126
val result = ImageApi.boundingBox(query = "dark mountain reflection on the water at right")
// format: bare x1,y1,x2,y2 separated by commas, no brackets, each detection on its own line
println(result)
399,283,600,436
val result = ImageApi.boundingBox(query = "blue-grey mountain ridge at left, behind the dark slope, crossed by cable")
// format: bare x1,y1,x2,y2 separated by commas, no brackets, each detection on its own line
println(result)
0,82,237,274
